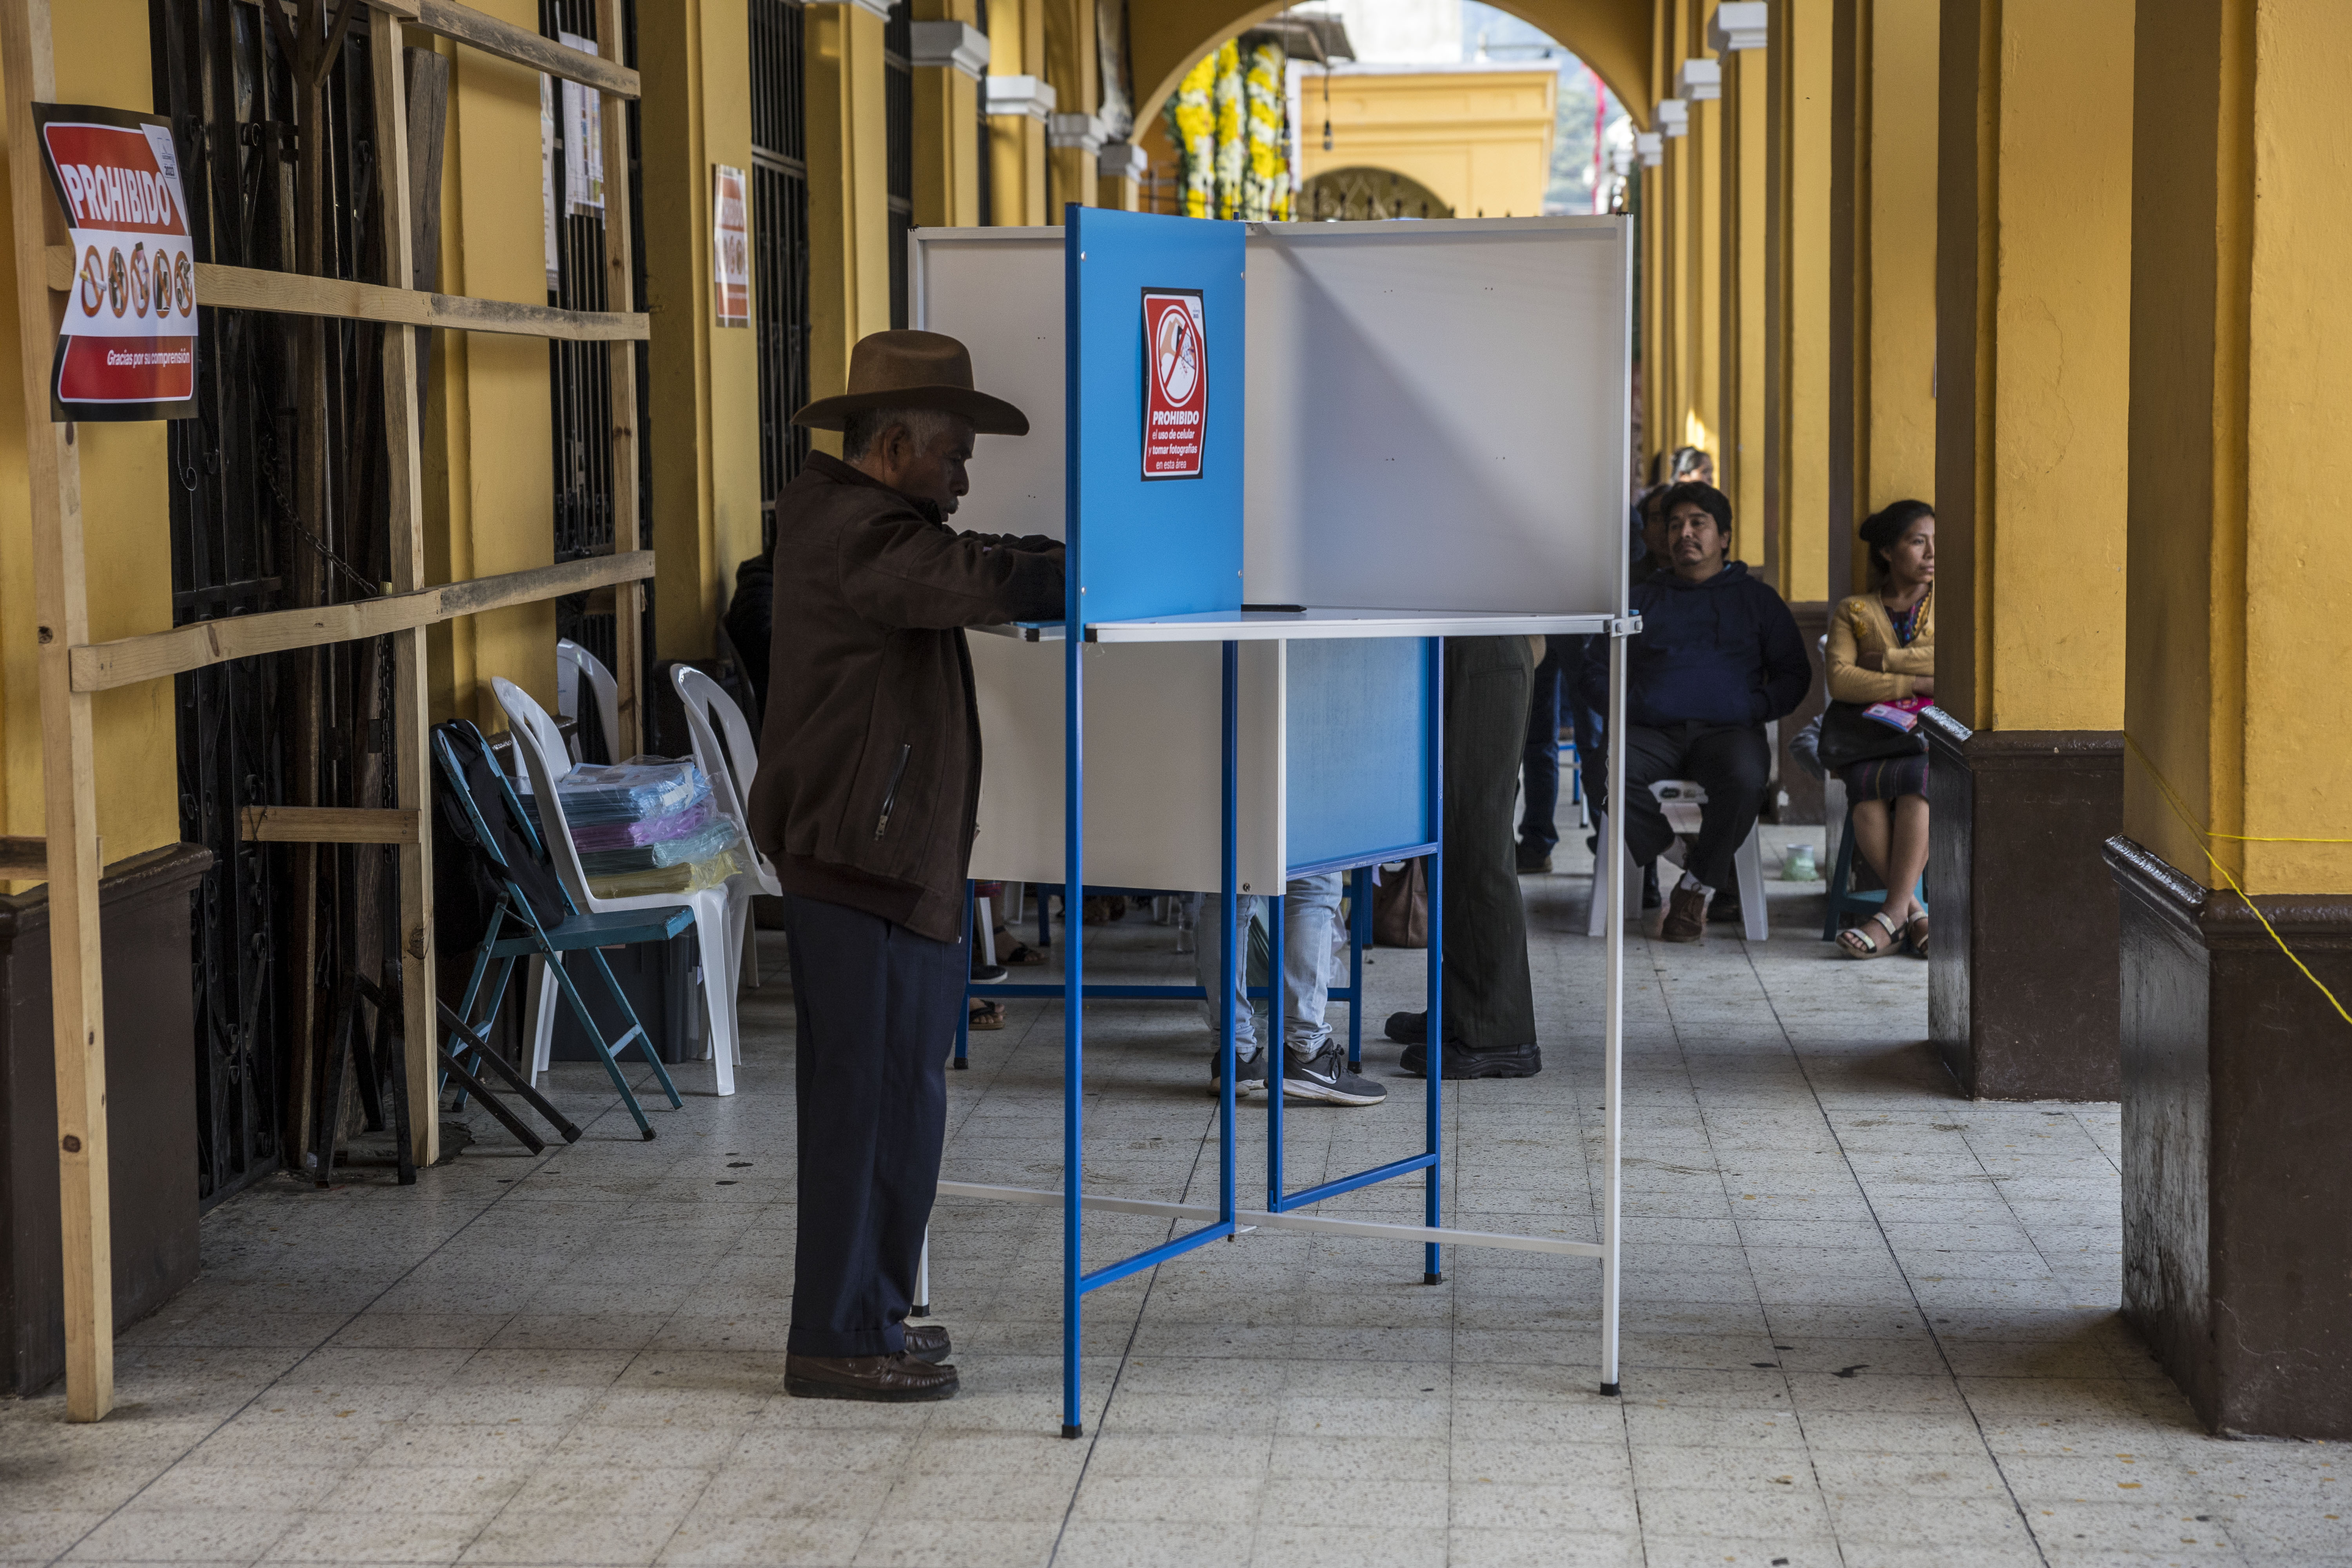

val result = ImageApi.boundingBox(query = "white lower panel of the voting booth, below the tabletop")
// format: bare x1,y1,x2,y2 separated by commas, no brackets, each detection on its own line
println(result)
971,635,1282,893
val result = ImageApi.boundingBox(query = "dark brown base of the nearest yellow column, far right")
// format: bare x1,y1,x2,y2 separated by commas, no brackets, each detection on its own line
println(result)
2105,837,2352,1441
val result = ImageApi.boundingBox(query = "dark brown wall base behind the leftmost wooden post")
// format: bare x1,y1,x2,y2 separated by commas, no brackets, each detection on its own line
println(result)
0,844,212,1396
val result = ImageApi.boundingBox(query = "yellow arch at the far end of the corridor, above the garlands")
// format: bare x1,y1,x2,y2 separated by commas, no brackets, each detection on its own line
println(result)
1127,0,1653,129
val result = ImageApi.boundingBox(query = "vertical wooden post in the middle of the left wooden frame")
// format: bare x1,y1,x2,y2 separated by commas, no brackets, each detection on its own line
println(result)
367,14,440,1171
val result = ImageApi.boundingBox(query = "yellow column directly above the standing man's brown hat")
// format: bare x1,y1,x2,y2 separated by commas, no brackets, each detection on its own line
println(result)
804,0,889,451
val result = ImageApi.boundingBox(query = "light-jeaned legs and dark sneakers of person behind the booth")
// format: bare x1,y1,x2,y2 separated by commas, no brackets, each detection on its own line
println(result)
1192,872,1388,1105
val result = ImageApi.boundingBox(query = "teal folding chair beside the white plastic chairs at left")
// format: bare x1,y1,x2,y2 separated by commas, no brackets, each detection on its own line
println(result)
433,719,694,1140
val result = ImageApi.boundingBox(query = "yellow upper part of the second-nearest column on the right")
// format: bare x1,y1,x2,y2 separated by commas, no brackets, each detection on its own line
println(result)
1933,0,2133,731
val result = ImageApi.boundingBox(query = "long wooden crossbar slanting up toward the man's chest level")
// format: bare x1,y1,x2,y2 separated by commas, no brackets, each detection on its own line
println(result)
72,555,654,693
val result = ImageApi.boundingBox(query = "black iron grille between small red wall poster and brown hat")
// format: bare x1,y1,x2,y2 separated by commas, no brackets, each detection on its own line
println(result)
750,0,809,555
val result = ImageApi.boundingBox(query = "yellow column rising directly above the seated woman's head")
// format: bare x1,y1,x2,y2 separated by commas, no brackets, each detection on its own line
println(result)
1828,0,1938,599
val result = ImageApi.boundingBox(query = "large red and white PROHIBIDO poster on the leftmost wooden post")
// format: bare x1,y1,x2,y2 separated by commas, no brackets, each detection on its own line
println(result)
33,103,198,421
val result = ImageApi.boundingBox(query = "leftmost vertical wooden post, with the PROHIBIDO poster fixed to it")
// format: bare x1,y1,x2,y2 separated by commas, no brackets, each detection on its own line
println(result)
0,0,115,1420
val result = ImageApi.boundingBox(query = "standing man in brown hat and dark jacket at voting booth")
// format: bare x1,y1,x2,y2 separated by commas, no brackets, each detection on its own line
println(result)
750,332,1063,1401
